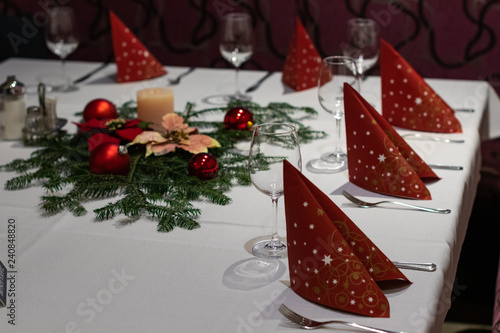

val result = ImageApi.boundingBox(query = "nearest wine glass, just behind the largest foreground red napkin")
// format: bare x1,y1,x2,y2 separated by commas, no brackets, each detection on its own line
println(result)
248,123,302,258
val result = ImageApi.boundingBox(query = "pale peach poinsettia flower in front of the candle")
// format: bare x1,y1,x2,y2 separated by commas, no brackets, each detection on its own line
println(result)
128,113,220,157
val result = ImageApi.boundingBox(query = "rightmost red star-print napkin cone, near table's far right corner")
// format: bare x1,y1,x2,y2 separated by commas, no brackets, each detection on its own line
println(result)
380,39,462,133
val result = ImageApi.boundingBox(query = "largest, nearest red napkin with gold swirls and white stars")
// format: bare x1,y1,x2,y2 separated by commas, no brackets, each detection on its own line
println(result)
283,160,409,317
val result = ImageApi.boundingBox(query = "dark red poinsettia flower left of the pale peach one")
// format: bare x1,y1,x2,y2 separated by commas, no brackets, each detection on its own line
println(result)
74,118,143,150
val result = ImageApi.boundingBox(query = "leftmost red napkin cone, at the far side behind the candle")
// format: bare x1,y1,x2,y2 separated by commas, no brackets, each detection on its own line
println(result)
109,11,167,83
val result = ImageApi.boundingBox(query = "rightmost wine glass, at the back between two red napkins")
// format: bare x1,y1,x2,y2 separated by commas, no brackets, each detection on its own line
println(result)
343,18,379,78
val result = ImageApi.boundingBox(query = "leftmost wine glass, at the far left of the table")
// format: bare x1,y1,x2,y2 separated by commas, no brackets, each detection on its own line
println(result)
45,6,79,91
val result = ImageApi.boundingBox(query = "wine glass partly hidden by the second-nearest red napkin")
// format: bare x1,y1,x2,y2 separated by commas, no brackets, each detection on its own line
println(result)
307,56,360,173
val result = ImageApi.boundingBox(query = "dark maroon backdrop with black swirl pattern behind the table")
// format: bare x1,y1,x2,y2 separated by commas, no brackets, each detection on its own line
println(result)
0,0,500,90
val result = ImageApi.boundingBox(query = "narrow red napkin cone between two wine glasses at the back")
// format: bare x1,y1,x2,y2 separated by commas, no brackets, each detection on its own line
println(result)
281,18,321,91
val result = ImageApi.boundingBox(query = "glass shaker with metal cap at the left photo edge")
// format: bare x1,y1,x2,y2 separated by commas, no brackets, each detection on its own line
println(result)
0,75,26,140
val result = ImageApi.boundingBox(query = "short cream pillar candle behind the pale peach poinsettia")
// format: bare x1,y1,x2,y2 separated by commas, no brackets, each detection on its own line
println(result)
137,88,174,128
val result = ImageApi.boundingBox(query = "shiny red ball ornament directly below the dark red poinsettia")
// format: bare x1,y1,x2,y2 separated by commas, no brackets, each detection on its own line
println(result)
90,142,130,176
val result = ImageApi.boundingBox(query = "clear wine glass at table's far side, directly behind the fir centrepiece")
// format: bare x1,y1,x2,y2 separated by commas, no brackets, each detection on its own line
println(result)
219,13,254,101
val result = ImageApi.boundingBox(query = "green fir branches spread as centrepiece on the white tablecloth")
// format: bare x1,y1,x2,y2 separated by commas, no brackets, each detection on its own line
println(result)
0,101,326,231
